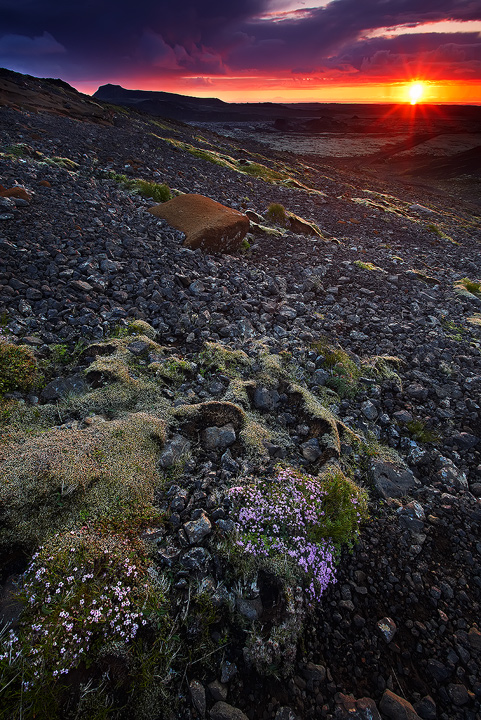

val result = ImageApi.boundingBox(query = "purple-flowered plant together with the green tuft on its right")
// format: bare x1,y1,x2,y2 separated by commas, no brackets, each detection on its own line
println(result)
230,468,365,602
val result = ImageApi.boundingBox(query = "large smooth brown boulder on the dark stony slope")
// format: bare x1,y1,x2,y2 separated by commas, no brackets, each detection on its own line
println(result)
149,194,249,252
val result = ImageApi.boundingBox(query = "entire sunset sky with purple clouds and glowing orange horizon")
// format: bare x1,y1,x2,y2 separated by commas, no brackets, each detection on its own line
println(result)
0,0,481,104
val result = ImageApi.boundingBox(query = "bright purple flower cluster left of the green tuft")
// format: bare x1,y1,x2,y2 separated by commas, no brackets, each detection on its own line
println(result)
230,468,335,602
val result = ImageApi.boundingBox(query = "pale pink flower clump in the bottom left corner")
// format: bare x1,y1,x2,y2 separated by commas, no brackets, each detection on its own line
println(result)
16,531,149,682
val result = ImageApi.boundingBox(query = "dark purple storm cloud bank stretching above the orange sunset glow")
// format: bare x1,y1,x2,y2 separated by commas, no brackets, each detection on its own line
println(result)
0,0,481,80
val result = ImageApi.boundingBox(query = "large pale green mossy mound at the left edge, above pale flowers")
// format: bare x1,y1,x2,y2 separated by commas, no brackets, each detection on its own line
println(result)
0,413,165,548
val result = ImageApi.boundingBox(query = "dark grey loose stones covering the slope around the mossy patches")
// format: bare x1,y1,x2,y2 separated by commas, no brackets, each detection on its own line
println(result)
0,77,481,720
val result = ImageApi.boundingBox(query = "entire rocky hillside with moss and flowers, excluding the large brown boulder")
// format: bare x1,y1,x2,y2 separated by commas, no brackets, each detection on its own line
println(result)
0,69,481,720
